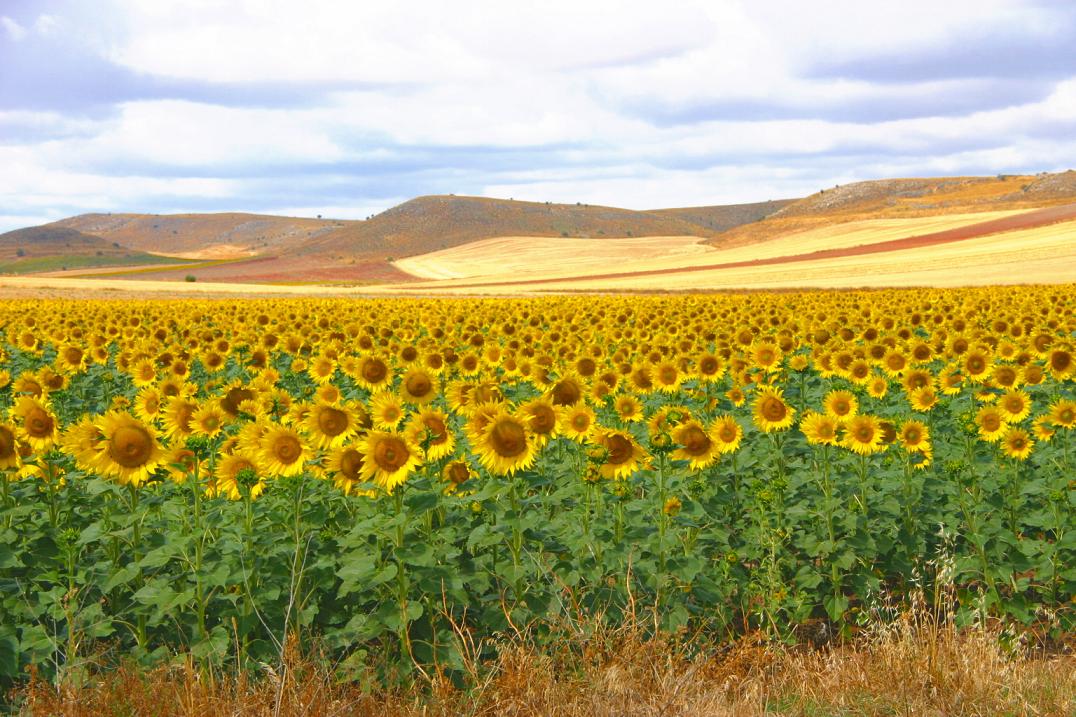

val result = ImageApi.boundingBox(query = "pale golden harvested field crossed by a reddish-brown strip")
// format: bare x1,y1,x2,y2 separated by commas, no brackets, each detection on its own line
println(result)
372,206,1076,294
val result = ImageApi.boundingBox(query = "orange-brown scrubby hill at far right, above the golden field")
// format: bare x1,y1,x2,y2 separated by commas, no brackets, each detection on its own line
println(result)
709,170,1076,247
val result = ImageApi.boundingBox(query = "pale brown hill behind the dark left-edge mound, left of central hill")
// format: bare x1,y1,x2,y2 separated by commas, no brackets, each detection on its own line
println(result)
52,212,349,258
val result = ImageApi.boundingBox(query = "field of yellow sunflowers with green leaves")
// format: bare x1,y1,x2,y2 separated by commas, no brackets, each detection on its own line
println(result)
0,286,1076,680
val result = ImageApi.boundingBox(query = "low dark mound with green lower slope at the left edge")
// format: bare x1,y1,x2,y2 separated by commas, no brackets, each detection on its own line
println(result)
0,224,182,273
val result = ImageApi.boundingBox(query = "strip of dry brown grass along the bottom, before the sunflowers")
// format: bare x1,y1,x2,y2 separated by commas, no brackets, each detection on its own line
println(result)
16,617,1076,717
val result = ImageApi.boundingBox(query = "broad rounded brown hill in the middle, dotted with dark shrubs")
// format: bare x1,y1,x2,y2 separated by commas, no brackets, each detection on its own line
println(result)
296,196,714,258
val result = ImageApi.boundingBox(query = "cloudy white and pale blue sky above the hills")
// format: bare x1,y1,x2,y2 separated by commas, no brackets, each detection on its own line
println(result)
0,0,1076,231
